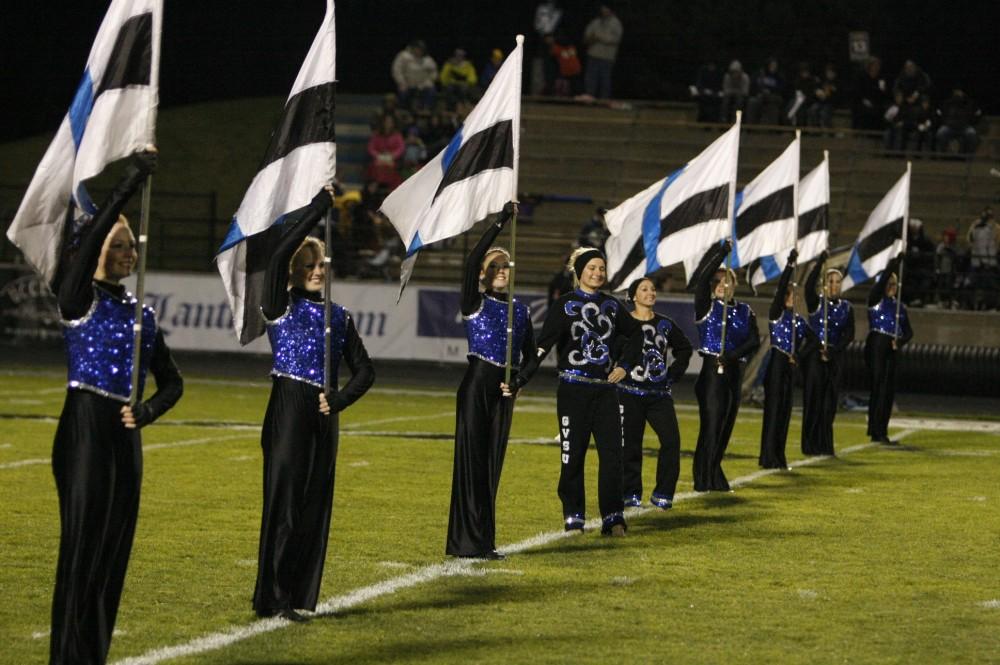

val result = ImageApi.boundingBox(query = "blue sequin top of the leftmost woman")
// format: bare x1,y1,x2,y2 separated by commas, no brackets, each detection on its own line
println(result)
63,285,156,402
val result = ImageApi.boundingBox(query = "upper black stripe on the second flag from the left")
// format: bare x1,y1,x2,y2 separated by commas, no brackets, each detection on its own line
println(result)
258,81,337,170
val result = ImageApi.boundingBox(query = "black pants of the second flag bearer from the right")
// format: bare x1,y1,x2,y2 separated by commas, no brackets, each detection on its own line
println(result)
802,349,844,455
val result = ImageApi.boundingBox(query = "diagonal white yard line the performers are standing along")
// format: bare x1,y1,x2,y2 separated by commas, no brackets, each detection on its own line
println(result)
107,430,916,665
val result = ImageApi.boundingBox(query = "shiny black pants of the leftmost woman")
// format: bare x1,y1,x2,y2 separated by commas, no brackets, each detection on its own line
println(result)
49,390,142,665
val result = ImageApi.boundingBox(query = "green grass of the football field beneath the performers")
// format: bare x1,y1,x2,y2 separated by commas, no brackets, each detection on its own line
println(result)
0,372,1000,665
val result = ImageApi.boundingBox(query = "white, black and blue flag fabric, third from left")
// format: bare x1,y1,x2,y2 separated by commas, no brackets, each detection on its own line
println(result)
380,36,523,293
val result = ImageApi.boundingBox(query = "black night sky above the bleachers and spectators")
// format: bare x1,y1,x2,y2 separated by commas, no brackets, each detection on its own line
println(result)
0,0,1000,140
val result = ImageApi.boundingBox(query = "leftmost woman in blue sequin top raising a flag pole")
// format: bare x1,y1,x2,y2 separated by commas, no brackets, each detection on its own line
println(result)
49,149,184,665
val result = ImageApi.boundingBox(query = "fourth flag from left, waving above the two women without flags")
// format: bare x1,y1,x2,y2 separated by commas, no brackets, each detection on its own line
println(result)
604,122,740,290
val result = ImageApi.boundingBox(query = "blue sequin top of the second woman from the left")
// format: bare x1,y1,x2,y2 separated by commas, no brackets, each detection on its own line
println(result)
267,292,350,388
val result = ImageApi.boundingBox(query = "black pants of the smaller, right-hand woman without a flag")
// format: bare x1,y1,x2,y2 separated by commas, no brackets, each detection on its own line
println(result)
618,390,681,499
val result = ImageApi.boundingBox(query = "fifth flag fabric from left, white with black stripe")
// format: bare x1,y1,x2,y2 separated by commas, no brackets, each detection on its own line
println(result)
727,137,799,268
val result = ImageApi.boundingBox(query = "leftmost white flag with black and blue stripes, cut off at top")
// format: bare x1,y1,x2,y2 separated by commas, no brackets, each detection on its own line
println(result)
7,0,163,286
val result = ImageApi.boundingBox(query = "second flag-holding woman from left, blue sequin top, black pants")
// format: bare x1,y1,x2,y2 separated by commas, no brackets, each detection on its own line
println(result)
253,186,375,621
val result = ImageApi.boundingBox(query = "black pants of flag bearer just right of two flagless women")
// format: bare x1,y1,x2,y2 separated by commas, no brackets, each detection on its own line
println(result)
694,356,743,492
